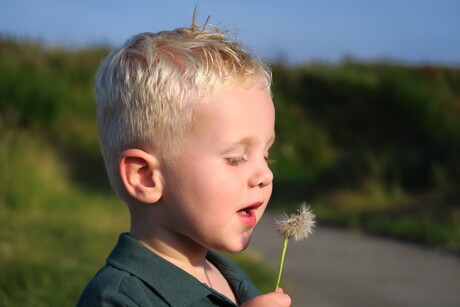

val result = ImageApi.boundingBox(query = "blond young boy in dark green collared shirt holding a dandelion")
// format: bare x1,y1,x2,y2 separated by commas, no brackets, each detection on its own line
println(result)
78,17,290,307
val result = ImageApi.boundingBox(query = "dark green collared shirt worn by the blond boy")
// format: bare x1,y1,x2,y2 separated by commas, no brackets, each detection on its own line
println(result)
77,233,260,307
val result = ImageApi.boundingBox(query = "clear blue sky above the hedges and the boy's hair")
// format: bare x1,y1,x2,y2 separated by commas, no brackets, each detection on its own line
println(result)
0,0,460,66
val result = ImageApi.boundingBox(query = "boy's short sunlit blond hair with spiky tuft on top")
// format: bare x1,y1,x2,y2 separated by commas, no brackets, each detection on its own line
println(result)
95,18,271,200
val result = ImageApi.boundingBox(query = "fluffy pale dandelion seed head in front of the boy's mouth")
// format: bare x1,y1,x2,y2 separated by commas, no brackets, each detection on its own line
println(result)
275,203,315,241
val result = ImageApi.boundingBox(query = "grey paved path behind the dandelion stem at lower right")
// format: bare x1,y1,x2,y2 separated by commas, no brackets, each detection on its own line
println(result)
248,214,460,307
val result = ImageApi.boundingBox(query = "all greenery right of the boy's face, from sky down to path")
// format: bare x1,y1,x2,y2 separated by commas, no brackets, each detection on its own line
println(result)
273,62,460,250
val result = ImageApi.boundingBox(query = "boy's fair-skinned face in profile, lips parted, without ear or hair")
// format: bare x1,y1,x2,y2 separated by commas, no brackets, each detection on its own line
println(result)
160,87,275,252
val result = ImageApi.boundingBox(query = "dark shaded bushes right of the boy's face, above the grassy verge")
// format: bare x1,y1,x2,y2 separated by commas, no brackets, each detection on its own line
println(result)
273,63,460,191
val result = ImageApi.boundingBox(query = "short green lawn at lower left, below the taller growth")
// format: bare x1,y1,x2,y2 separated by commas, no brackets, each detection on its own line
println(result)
0,195,126,306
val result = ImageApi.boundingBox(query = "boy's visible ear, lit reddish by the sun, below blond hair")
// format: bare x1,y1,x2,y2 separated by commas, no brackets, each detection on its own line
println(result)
118,149,163,204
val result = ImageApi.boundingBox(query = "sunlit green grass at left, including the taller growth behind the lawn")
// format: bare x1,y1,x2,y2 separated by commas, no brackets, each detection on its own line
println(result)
0,130,127,306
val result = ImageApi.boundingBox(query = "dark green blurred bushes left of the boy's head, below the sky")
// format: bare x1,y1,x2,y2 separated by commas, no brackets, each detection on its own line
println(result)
0,37,108,189
